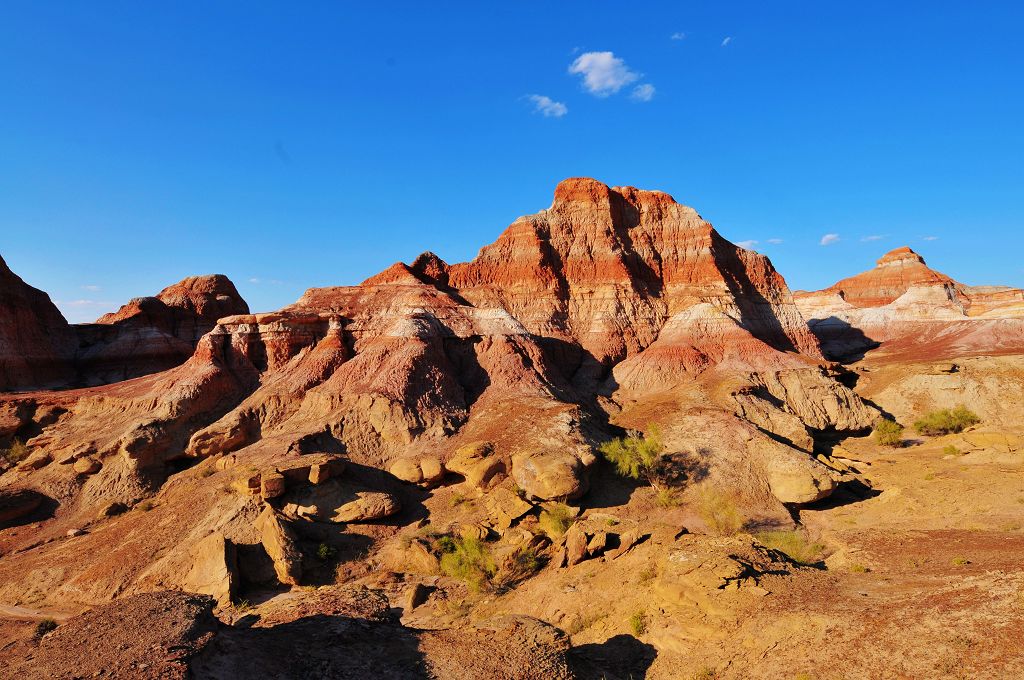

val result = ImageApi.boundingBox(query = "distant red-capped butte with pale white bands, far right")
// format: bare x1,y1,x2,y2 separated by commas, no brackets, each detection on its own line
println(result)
796,247,1024,359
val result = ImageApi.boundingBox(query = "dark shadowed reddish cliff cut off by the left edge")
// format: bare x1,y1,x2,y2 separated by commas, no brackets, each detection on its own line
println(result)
0,258,76,392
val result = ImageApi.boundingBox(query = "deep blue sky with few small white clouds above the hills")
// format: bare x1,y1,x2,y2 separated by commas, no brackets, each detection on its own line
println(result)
0,0,1024,322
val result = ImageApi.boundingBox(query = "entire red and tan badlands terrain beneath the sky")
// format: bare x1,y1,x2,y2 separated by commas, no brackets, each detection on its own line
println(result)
0,178,1024,680
